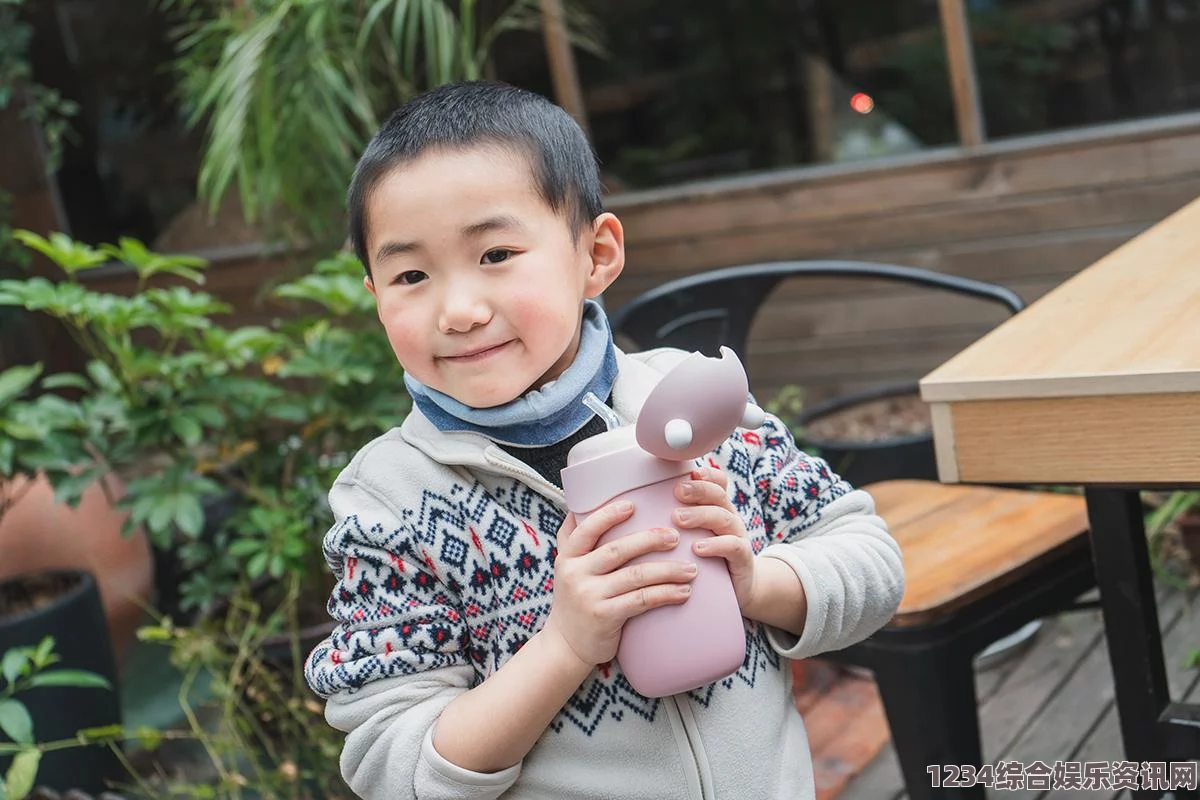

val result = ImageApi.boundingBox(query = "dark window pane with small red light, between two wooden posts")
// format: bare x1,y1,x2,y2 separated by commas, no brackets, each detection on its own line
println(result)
497,0,955,191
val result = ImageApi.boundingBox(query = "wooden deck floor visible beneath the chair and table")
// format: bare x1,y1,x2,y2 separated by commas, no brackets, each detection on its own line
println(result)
797,587,1200,800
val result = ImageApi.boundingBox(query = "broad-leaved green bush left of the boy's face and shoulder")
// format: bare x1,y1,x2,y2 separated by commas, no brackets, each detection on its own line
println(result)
0,231,409,610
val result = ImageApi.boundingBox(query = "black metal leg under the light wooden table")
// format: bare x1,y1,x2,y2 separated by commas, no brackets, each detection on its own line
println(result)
1085,489,1170,799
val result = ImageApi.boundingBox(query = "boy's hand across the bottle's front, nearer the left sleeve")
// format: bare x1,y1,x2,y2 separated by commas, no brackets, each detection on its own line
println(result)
544,503,696,667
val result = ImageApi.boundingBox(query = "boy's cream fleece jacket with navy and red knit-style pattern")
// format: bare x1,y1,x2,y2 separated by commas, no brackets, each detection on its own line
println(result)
305,349,904,800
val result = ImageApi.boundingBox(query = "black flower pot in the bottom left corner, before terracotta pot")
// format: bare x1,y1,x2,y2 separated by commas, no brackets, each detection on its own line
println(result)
0,570,128,793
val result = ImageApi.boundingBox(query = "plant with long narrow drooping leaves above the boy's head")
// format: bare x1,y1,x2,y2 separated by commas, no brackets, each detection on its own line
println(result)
163,0,600,245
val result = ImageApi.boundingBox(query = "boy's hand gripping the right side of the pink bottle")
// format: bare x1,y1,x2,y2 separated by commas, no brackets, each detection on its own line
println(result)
674,468,758,613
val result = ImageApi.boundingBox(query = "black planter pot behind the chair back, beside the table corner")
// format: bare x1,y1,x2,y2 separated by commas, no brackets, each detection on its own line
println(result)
799,384,937,487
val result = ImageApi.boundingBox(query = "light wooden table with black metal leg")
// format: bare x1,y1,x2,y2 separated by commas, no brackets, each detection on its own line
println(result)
920,199,1200,798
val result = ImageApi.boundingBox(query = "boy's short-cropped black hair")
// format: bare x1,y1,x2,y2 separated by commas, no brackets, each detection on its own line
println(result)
346,80,604,275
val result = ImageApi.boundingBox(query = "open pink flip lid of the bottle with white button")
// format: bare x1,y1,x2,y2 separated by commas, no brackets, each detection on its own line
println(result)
637,347,763,461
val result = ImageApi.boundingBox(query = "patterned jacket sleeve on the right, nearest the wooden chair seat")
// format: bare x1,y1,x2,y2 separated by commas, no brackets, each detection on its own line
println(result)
742,414,905,658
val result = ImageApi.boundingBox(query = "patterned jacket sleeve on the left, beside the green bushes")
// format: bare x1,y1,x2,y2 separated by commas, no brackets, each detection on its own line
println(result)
305,480,521,800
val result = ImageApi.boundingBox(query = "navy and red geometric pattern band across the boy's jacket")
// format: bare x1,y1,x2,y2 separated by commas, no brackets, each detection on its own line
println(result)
306,415,851,735
